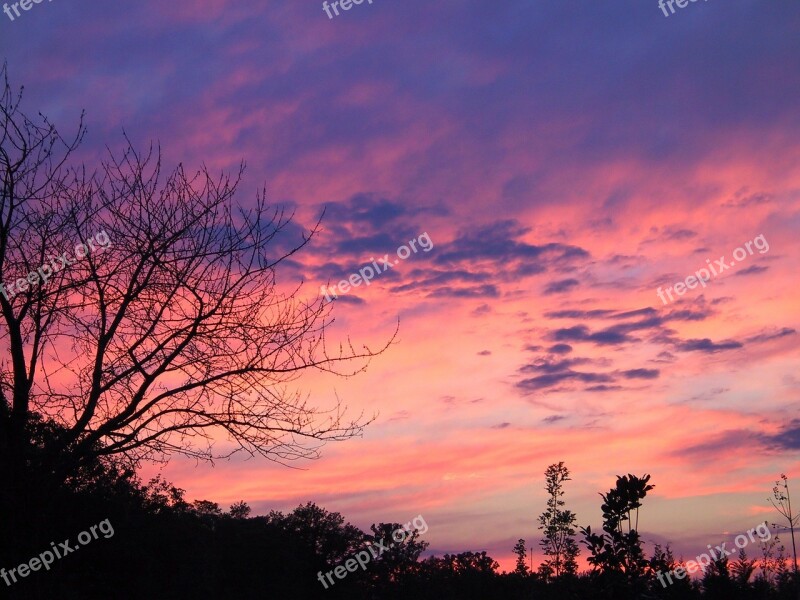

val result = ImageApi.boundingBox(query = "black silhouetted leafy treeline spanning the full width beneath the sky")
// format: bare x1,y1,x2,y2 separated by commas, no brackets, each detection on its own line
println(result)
0,428,798,600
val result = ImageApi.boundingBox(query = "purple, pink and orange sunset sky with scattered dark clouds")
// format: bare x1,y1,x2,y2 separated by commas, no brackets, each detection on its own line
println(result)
0,0,800,569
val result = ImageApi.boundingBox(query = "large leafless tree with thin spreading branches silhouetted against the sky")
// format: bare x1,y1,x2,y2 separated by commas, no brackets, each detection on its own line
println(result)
0,67,394,492
